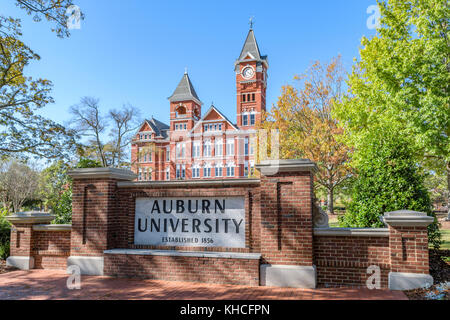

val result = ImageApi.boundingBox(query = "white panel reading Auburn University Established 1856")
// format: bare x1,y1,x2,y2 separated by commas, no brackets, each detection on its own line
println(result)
134,197,245,248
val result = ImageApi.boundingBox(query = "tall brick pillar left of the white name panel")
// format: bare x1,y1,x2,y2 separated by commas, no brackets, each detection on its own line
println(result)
67,168,136,275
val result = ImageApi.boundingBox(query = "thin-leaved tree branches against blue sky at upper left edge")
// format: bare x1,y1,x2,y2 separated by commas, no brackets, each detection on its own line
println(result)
0,0,81,158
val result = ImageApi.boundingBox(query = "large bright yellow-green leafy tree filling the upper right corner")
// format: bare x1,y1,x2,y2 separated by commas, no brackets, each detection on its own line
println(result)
336,0,450,217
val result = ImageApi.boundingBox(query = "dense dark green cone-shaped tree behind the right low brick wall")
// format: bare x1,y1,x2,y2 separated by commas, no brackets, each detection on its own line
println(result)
339,129,440,247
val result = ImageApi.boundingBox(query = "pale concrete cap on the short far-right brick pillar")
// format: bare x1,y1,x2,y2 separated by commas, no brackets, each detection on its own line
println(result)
382,210,434,227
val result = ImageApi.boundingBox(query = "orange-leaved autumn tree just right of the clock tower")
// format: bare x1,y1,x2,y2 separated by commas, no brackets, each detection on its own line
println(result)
260,57,352,212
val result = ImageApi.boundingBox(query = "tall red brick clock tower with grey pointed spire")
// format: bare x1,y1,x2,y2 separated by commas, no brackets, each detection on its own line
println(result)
234,27,269,130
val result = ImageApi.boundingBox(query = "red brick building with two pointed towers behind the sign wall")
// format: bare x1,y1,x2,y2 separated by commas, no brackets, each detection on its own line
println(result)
131,29,269,181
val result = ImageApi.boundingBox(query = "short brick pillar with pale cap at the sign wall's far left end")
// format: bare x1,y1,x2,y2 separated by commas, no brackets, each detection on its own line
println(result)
6,212,55,270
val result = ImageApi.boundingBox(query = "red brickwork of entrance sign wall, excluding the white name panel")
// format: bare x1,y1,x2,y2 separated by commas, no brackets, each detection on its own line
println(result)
9,160,432,287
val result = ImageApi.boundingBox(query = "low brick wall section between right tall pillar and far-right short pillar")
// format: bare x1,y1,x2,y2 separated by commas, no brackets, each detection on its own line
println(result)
314,230,390,288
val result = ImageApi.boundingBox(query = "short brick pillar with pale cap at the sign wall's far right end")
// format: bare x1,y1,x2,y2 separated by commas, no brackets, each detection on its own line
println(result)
383,210,434,290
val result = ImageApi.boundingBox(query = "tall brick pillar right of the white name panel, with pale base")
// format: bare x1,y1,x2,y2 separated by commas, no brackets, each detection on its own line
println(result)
256,160,316,288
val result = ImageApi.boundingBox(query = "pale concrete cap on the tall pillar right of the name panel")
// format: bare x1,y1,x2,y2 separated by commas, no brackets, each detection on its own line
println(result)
255,159,317,176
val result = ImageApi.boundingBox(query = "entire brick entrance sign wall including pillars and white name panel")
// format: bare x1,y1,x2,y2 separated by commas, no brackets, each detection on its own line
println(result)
8,160,433,289
